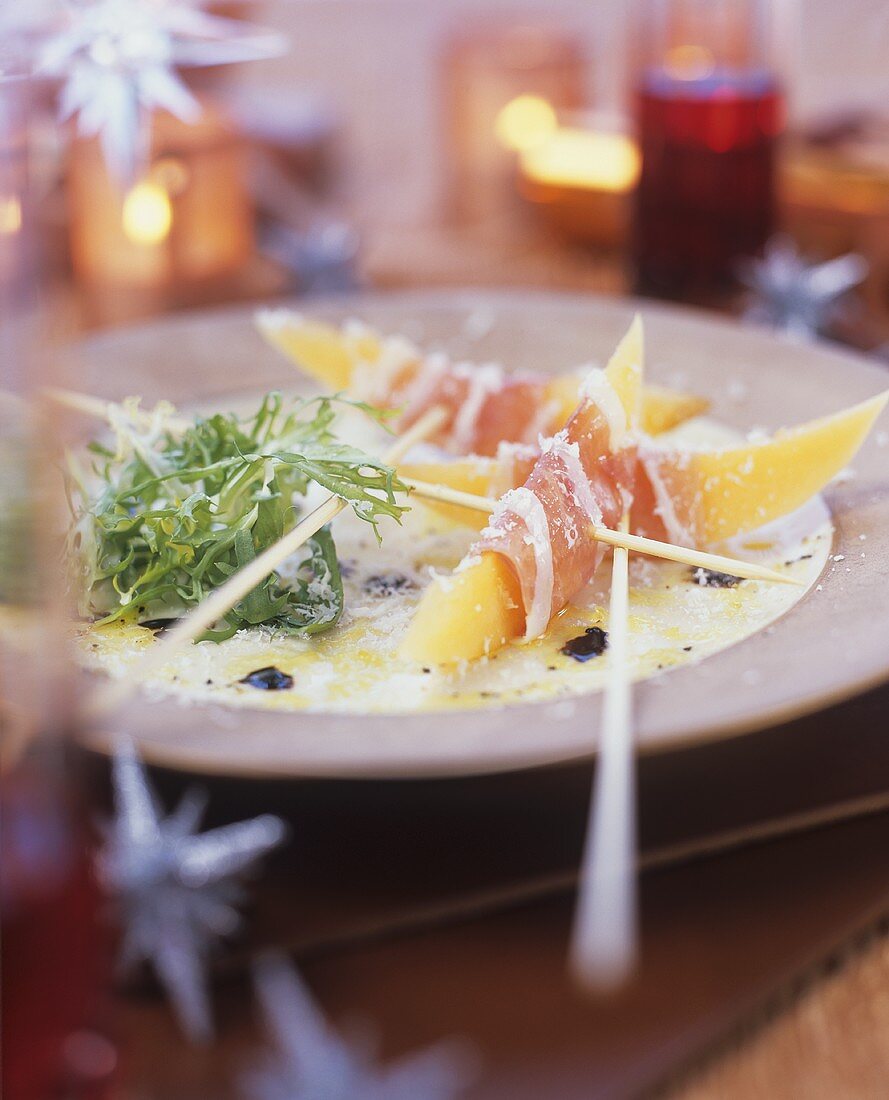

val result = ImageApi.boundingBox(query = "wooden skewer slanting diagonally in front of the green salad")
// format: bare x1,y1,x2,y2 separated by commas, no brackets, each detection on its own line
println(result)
87,406,448,718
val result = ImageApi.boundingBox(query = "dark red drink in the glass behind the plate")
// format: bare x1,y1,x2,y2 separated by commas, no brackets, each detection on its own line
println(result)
633,70,782,298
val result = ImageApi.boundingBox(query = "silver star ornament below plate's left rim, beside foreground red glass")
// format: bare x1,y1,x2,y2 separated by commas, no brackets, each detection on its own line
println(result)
98,740,286,1042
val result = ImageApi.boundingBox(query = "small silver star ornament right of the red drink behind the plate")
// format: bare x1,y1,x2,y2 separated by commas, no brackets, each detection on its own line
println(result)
739,237,867,339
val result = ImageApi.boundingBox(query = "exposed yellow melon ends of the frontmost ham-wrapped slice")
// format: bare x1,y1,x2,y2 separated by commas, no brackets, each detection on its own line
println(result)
400,317,643,664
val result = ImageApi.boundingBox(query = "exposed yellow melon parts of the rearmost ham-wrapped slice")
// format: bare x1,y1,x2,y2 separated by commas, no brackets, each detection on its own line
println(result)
256,309,710,436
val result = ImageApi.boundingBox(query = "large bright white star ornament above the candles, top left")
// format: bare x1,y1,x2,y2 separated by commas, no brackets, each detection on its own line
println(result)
37,0,284,179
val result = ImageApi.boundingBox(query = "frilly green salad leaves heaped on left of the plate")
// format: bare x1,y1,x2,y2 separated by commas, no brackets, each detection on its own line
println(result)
67,393,407,641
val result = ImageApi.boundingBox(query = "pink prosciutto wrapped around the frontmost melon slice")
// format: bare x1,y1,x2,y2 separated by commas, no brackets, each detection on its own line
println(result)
470,371,636,641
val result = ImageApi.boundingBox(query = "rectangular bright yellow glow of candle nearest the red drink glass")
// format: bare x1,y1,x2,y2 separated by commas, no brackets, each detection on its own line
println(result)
522,127,639,193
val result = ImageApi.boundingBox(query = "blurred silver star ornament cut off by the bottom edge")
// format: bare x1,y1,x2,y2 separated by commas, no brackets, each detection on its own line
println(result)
242,955,475,1100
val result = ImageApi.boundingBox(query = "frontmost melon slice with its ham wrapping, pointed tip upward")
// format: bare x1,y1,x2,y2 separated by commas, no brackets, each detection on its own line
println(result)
403,319,643,663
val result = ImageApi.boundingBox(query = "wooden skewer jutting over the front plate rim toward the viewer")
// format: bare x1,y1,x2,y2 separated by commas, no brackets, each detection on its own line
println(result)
570,516,638,991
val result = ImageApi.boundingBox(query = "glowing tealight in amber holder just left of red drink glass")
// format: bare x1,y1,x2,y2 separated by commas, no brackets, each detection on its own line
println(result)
519,127,639,248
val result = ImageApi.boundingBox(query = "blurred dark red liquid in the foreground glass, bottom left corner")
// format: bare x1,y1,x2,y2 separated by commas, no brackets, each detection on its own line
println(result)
0,766,113,1100
